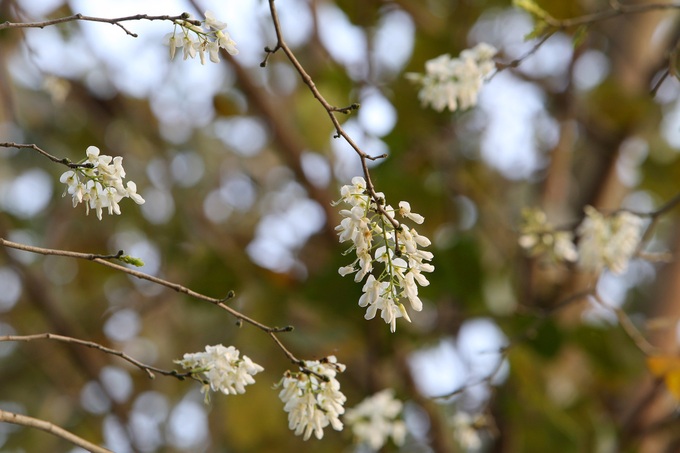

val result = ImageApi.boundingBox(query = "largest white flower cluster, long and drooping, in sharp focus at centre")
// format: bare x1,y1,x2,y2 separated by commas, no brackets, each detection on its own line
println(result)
335,176,434,332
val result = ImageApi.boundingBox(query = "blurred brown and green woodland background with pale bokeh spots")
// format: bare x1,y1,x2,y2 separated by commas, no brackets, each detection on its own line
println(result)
0,0,680,452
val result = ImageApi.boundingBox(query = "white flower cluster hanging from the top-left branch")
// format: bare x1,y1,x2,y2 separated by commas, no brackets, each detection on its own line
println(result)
165,11,238,64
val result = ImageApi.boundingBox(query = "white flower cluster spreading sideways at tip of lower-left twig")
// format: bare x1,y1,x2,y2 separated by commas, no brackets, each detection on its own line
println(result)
175,344,264,403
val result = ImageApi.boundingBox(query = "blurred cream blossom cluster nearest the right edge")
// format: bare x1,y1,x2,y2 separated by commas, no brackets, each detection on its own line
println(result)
578,206,643,274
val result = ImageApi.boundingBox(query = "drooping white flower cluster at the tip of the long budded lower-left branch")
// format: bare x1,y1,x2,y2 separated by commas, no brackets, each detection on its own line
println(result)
279,356,347,440
